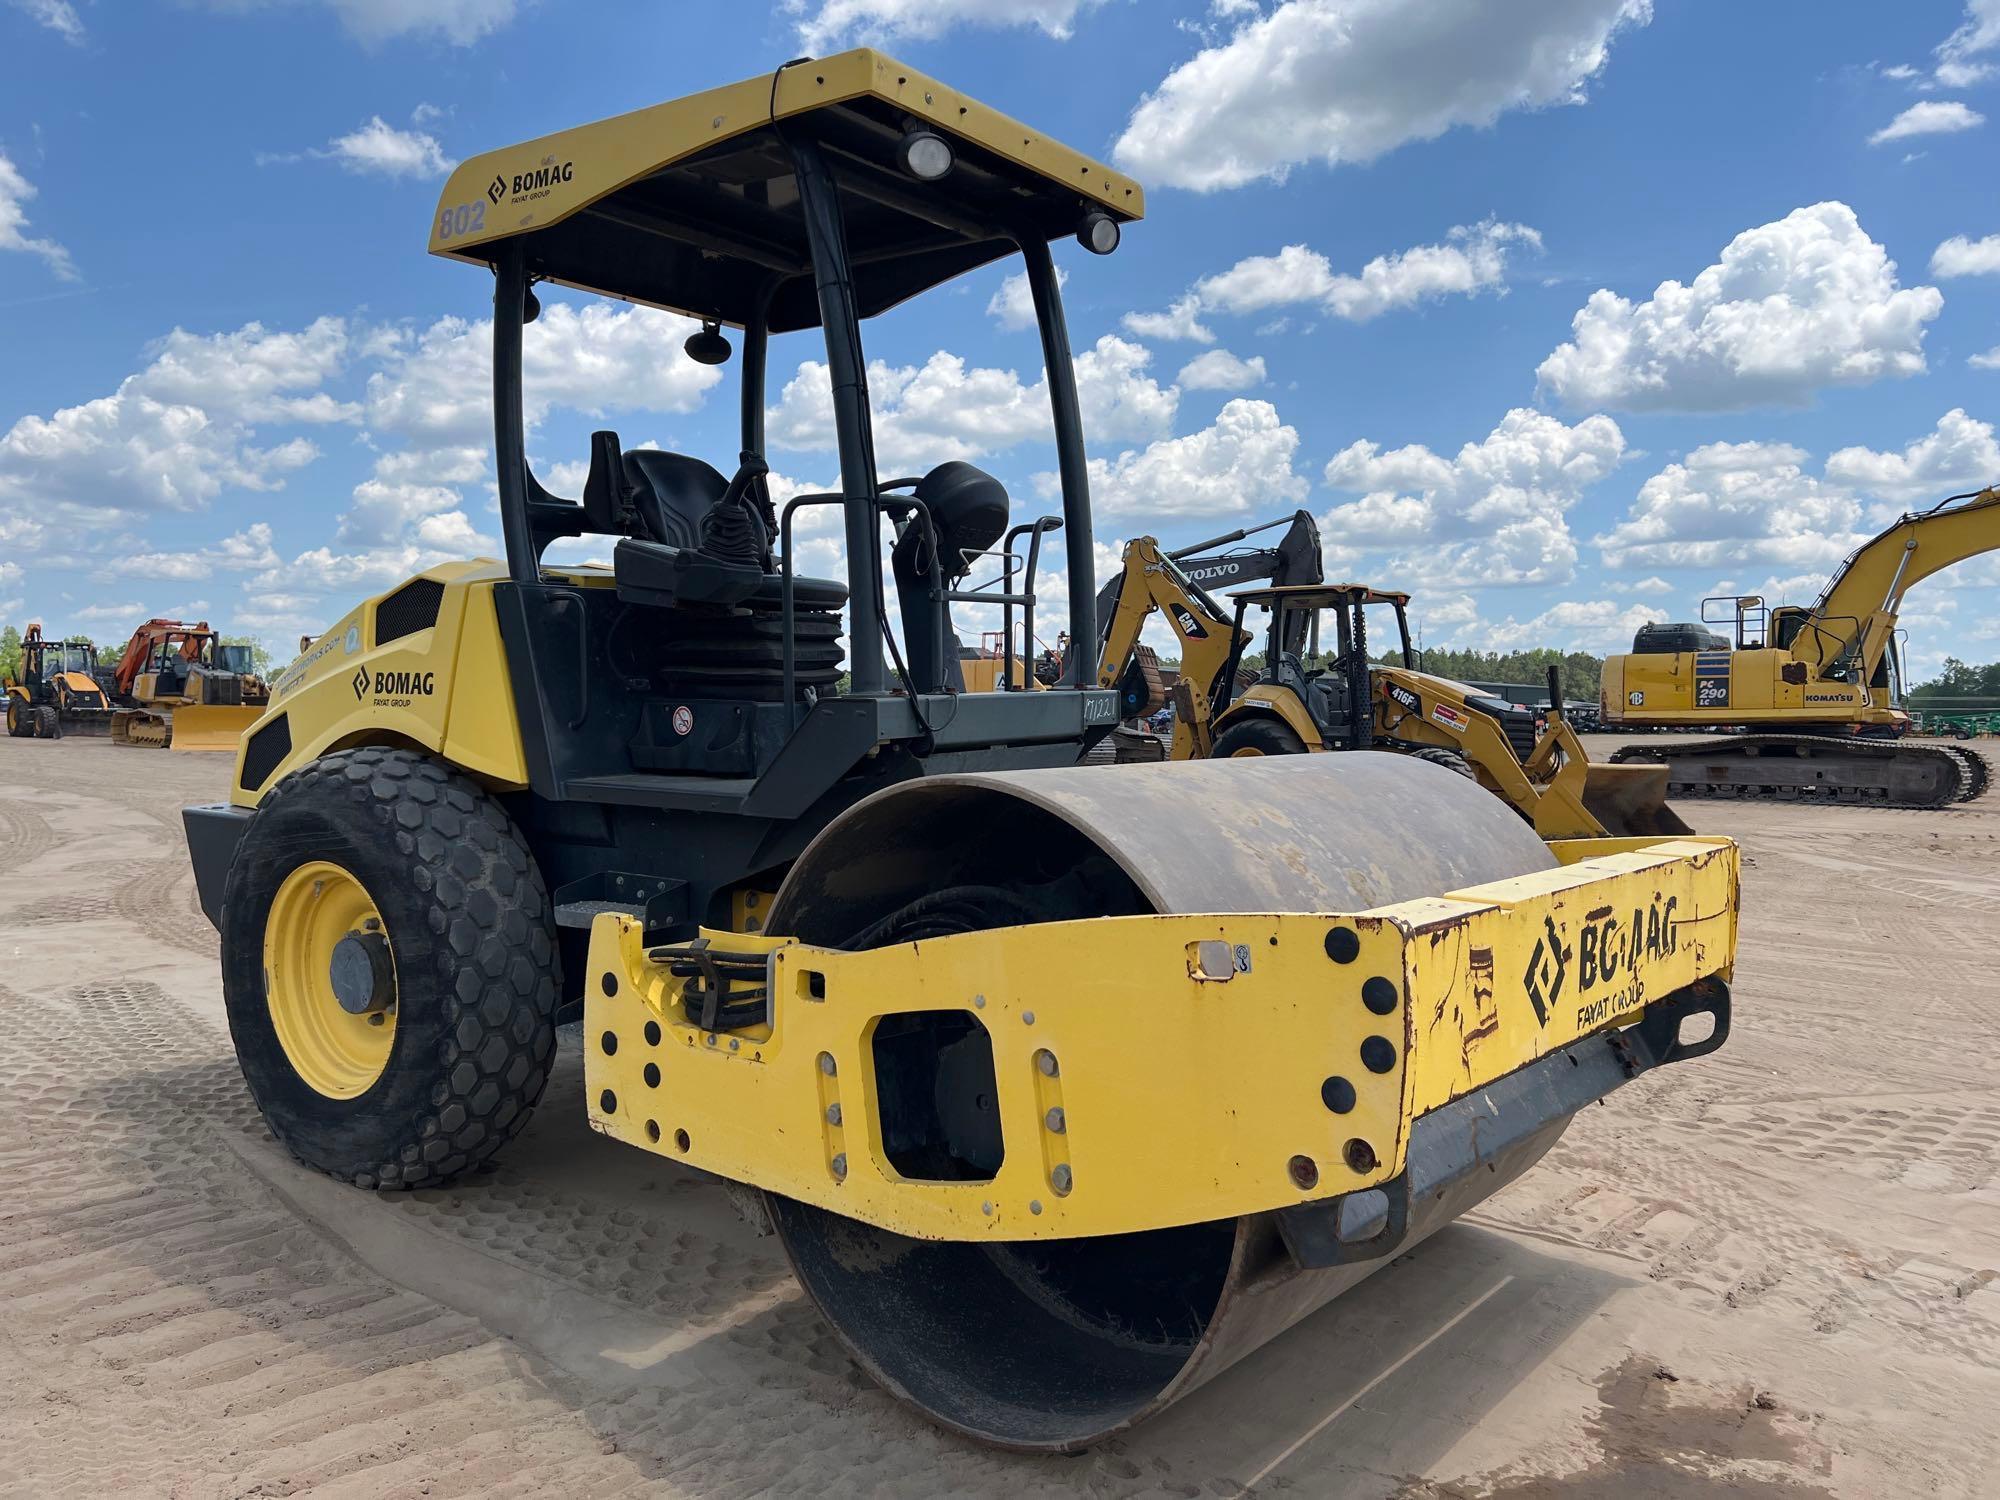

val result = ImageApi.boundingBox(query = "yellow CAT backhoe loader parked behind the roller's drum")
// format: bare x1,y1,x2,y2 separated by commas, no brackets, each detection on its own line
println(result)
1098,528,1690,838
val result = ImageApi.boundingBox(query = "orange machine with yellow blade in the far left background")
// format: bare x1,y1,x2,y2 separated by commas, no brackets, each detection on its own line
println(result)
112,620,270,752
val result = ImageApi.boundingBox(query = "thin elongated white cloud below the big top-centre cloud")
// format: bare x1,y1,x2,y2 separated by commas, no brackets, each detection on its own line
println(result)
1196,220,1542,322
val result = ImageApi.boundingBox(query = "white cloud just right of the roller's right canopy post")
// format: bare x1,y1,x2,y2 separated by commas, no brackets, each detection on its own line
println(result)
1064,396,1308,518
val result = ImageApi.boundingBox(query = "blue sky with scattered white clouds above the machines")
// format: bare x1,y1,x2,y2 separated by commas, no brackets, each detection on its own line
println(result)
0,0,2000,670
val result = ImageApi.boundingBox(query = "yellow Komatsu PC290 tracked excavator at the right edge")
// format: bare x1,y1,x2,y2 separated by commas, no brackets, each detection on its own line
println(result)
1600,488,2000,808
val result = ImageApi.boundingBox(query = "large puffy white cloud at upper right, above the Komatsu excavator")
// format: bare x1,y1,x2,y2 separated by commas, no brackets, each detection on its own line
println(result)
1536,202,1944,412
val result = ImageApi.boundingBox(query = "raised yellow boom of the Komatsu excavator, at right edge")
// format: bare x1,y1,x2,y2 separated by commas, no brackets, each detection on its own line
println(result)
1790,488,2000,682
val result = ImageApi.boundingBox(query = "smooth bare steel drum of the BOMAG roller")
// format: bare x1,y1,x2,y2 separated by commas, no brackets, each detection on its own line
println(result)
768,754,1568,1452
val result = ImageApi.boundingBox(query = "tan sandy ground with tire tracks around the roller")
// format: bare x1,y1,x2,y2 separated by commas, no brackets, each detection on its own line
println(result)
0,738,2000,1500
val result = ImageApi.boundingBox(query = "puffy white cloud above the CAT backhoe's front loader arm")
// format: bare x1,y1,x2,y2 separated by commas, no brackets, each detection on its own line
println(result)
1320,408,1626,584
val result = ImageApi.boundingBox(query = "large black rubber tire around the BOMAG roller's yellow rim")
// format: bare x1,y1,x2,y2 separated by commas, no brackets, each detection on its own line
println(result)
220,748,562,1188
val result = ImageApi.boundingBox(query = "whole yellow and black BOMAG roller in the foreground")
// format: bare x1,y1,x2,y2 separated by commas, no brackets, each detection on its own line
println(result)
186,50,1736,1450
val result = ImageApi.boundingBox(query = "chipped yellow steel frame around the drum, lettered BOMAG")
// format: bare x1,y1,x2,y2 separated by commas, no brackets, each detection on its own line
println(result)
584,838,1738,1240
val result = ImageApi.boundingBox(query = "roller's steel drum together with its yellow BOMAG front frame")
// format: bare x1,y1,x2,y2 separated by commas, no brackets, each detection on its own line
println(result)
584,752,1736,1452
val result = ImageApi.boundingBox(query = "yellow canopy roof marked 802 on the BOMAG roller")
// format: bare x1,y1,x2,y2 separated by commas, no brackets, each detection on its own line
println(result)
430,48,1146,332
